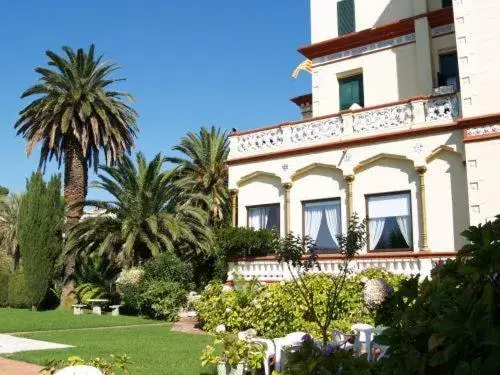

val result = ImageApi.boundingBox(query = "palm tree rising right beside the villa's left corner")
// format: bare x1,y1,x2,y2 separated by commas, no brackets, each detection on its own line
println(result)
168,127,229,225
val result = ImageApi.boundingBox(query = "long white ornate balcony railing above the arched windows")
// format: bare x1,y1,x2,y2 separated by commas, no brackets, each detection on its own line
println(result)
230,94,460,159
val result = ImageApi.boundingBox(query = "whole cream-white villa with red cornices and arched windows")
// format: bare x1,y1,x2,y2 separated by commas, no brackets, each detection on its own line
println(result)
228,0,500,281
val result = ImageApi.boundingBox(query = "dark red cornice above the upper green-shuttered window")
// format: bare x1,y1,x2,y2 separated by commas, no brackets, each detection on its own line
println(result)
298,7,453,60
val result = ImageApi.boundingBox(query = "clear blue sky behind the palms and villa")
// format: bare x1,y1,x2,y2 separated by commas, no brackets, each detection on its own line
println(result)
0,0,310,196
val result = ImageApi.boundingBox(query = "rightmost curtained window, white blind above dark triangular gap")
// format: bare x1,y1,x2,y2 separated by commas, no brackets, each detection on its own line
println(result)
367,192,413,250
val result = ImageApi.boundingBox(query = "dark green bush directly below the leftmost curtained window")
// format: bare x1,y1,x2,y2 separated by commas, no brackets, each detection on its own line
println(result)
216,227,276,258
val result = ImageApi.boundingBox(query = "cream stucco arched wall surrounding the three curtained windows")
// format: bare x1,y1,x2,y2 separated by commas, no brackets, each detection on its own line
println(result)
229,130,468,251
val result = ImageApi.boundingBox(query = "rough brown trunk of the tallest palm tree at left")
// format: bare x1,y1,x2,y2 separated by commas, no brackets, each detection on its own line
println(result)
60,137,88,308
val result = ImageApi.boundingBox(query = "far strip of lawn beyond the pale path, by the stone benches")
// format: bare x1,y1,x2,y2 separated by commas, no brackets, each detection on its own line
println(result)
0,308,158,333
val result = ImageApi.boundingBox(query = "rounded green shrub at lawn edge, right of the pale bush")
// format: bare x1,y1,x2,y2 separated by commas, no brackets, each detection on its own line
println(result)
142,281,186,321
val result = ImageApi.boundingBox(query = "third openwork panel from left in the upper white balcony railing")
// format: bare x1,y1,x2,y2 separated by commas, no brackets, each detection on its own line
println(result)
353,103,413,133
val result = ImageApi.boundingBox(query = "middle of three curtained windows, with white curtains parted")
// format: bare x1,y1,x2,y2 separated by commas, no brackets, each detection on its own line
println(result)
303,199,342,250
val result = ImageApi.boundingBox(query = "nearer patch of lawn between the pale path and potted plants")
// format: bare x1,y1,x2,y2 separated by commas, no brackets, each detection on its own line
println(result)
9,325,213,375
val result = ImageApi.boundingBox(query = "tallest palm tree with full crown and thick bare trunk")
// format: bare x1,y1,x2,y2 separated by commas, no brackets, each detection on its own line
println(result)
15,45,137,306
